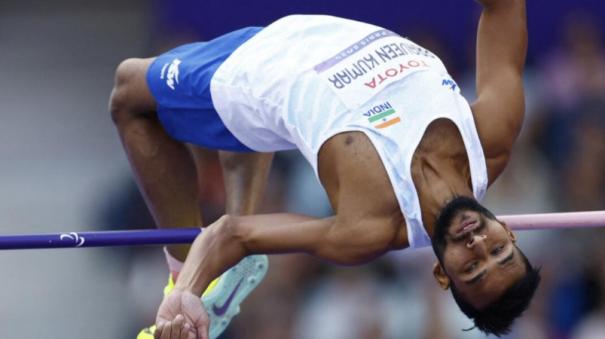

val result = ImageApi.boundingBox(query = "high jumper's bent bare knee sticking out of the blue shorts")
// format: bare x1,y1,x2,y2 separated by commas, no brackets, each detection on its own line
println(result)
109,58,153,124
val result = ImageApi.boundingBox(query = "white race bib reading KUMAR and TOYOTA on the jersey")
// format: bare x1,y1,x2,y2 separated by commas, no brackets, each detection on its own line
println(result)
313,29,441,109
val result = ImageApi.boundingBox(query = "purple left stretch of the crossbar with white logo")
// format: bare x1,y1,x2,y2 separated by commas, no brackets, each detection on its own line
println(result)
0,228,202,250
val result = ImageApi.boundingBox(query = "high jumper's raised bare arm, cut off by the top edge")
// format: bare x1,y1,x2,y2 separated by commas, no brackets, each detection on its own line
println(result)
472,0,527,184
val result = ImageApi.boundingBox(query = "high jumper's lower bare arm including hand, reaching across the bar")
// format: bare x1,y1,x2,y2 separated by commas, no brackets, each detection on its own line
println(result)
154,213,405,339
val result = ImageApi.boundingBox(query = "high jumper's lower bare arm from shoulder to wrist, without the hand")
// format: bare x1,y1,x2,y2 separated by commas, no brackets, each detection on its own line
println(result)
175,213,400,295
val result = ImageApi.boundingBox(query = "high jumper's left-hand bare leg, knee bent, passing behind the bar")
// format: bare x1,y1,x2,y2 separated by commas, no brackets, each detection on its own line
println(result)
110,59,202,260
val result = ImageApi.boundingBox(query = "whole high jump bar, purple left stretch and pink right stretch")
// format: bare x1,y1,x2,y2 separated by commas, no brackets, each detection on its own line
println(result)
0,211,605,250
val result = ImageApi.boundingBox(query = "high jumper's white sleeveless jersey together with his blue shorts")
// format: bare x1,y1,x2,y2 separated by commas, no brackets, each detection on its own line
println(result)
148,15,487,248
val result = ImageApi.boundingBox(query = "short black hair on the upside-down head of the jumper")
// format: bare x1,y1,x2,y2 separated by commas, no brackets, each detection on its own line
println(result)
451,250,540,337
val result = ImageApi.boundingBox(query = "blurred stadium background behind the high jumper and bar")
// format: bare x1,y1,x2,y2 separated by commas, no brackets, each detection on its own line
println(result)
0,0,605,339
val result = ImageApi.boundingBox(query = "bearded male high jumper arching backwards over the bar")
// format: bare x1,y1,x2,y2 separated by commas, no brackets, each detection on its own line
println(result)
111,0,539,338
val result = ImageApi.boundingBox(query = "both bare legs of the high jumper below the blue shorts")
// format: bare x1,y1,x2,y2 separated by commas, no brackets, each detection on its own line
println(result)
110,59,272,261
